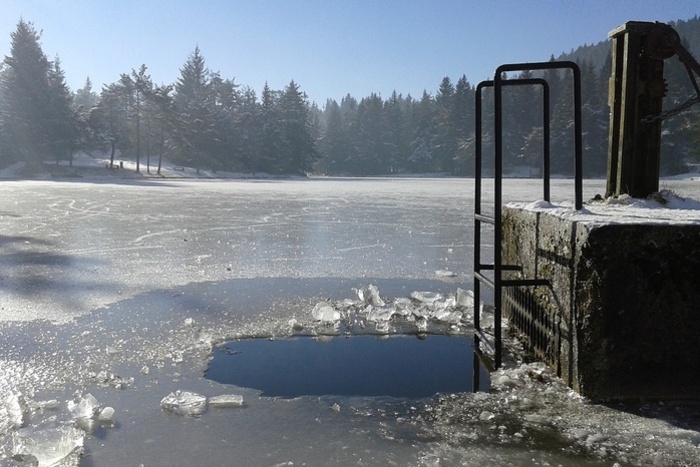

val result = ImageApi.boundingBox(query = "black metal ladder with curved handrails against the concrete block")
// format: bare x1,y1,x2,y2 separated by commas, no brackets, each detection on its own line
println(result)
473,61,583,372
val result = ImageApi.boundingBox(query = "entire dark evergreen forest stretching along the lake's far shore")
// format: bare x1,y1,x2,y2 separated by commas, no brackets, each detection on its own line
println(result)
0,17,700,177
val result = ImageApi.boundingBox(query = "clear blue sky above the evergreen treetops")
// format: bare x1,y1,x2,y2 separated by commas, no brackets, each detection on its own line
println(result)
0,0,700,106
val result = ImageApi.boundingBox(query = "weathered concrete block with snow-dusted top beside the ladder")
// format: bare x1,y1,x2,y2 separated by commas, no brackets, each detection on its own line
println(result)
503,205,700,400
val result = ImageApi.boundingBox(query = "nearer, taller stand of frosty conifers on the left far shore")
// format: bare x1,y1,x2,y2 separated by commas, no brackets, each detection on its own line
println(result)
0,20,319,174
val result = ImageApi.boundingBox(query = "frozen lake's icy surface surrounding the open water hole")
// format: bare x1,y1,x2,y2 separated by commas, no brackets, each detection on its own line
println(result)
0,179,700,466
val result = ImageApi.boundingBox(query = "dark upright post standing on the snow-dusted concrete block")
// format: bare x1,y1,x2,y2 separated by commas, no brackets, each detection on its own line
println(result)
606,21,666,198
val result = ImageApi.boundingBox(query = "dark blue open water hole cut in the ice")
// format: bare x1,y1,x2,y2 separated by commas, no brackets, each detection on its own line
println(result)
205,335,489,398
